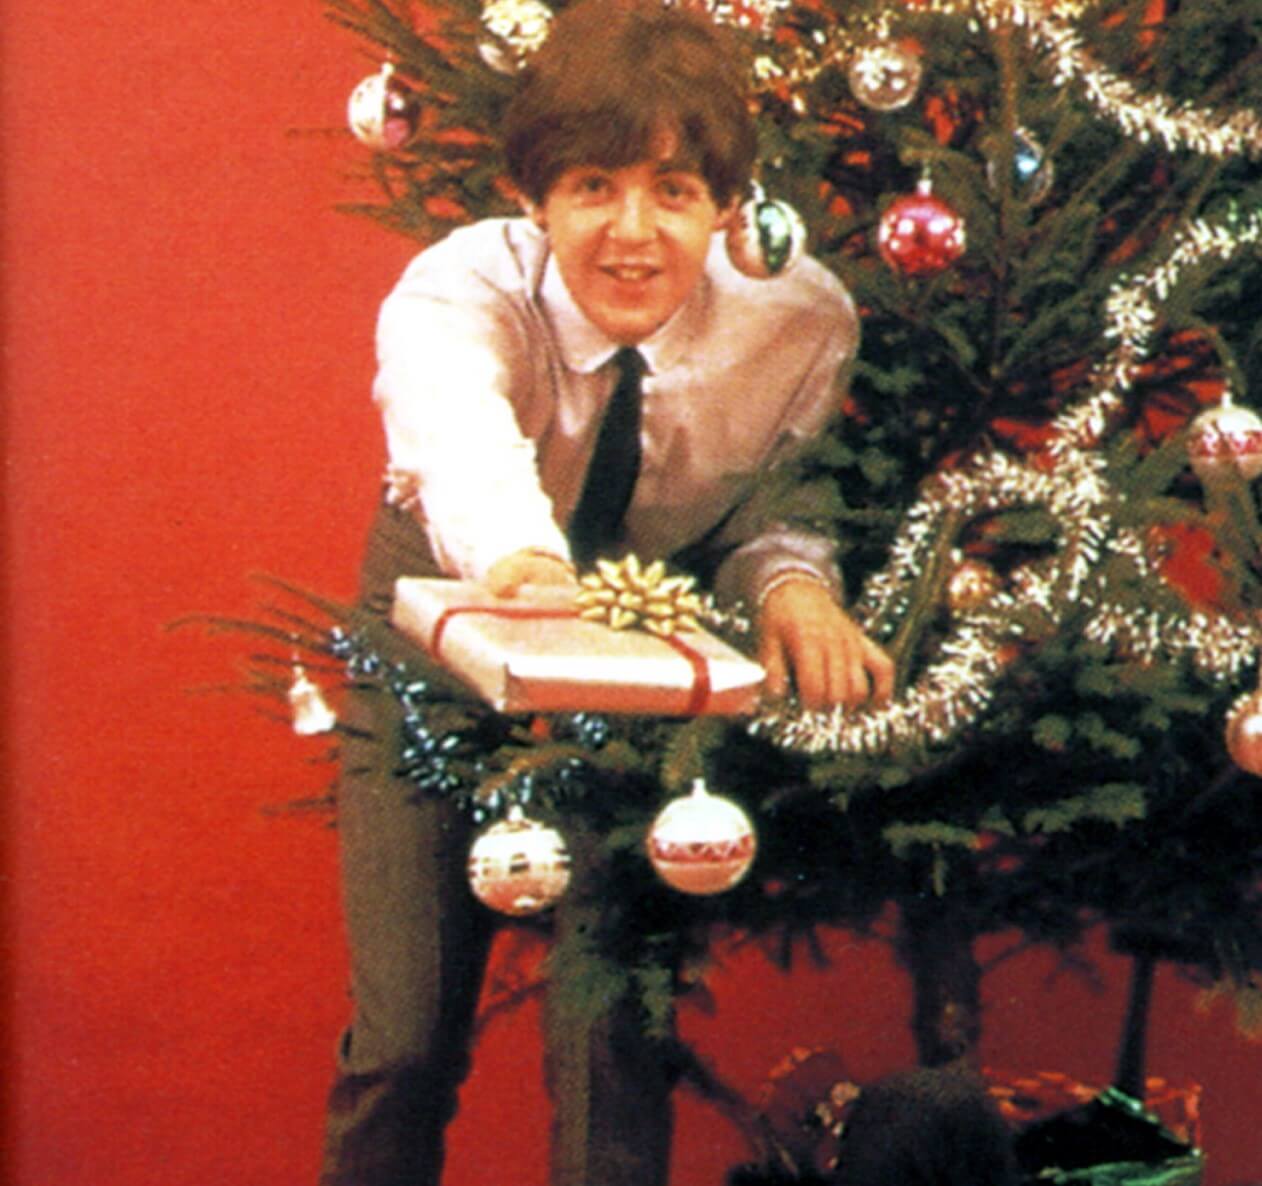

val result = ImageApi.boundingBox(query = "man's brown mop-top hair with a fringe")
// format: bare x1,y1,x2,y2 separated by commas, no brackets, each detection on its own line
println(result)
504,0,757,206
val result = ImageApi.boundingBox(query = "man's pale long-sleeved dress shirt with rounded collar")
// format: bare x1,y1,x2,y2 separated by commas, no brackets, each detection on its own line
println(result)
374,218,858,598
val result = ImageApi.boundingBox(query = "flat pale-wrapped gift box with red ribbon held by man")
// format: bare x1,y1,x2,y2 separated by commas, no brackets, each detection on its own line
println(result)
390,577,764,717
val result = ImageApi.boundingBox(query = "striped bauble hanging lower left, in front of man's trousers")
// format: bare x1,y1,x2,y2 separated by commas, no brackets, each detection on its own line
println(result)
468,806,569,917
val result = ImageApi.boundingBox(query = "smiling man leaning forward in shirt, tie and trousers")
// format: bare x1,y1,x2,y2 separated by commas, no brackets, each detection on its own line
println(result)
322,0,892,1186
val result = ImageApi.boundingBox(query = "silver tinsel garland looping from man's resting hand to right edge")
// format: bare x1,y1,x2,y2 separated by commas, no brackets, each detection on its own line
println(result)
753,209,1262,756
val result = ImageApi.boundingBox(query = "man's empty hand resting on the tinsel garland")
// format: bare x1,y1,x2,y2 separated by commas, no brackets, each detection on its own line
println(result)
758,575,893,709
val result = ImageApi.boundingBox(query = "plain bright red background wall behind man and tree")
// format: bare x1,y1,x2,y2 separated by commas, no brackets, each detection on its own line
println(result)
3,0,1262,1186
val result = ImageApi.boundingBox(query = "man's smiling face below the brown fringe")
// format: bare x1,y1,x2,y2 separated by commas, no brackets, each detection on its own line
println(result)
531,145,734,346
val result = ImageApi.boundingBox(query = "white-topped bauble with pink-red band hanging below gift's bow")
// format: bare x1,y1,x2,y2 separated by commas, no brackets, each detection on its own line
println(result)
647,778,757,895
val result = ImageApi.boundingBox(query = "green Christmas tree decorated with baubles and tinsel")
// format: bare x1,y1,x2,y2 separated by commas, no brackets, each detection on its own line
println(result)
246,0,1262,1170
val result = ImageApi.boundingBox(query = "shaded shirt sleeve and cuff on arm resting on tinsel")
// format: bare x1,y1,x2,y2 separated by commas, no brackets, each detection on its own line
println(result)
714,277,859,607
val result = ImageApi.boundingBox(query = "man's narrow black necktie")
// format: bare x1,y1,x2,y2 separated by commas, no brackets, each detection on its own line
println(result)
569,346,645,564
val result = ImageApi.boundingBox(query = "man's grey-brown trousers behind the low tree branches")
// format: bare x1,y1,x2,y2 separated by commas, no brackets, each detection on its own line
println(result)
321,508,673,1186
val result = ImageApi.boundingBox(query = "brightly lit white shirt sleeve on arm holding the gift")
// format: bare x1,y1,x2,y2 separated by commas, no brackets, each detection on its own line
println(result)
374,256,568,579
